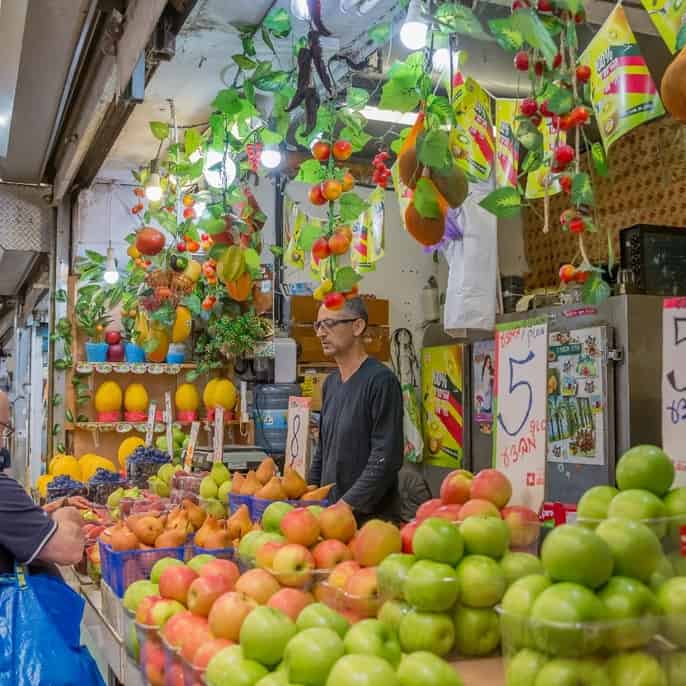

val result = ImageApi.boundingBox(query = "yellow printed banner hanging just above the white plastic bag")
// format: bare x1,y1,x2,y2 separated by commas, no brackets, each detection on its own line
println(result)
450,77,495,181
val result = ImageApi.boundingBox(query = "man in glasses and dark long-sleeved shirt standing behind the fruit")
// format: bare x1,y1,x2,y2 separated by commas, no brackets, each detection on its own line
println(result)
309,298,403,524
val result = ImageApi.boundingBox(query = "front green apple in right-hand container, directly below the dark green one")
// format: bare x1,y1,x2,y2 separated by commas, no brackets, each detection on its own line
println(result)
531,582,607,657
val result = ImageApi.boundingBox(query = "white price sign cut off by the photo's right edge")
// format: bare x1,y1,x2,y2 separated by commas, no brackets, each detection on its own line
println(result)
662,298,686,486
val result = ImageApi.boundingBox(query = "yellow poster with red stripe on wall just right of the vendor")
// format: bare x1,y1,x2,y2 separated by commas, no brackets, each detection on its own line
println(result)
422,345,464,469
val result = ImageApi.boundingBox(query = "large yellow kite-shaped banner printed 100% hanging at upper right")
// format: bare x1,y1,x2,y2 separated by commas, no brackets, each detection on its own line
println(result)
579,5,665,150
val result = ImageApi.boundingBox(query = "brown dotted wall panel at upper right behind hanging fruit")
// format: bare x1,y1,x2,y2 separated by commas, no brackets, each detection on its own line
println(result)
523,118,686,289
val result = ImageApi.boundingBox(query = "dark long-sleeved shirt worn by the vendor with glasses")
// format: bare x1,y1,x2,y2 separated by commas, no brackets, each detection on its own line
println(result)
309,358,403,516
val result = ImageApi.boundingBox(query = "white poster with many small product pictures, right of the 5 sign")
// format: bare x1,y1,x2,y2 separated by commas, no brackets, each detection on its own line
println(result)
548,326,607,465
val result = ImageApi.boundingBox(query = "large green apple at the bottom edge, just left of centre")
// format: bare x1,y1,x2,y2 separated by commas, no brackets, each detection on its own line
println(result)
283,628,345,686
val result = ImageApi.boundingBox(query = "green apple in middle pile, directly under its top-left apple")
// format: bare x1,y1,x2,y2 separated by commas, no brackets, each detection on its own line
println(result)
403,560,460,612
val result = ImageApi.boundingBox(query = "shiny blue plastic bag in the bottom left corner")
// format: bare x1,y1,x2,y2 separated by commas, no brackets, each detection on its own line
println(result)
0,567,104,686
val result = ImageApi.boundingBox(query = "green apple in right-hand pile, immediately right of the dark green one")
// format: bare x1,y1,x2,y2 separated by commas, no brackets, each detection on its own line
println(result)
596,518,662,582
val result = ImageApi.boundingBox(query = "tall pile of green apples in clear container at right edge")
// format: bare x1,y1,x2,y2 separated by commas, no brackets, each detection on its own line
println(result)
500,446,686,686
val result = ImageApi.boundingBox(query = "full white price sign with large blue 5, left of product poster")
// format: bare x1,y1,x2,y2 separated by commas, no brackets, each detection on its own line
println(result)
493,318,548,512
